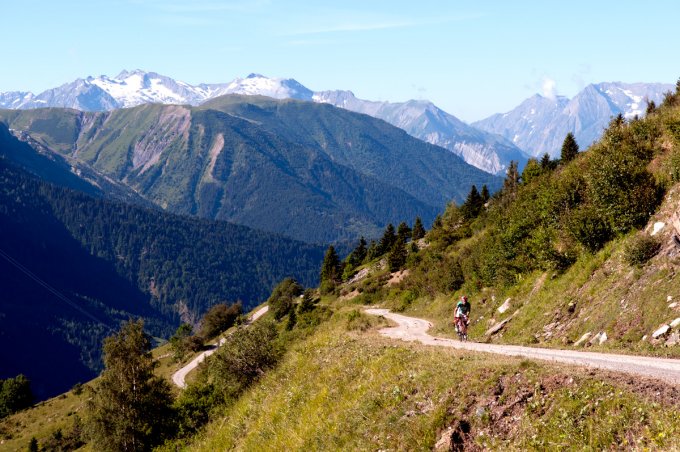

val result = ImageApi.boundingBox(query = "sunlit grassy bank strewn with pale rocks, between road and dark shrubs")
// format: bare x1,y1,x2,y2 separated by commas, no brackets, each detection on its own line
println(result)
385,181,680,357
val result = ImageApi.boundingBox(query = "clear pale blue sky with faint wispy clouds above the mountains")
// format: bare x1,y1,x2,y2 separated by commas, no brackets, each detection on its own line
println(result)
0,0,680,121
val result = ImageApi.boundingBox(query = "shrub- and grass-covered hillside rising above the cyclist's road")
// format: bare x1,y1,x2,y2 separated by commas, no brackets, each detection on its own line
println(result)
344,84,680,355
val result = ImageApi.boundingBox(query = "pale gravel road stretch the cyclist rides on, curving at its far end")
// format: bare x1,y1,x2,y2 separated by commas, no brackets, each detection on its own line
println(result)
366,308,680,385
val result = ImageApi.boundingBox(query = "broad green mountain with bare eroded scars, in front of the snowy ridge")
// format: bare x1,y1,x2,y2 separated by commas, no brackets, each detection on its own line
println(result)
0,95,500,242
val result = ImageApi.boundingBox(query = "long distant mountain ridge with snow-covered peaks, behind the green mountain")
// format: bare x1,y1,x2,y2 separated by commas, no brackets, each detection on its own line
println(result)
0,70,527,174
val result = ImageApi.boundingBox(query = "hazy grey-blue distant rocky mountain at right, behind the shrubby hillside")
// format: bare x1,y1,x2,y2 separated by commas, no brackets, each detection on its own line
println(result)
472,82,675,157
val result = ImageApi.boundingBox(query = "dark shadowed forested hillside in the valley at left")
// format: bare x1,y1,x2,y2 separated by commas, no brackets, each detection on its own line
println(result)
0,159,322,397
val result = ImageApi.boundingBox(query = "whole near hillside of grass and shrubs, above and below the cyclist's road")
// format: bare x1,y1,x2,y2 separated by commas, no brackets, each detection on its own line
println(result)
3,90,680,450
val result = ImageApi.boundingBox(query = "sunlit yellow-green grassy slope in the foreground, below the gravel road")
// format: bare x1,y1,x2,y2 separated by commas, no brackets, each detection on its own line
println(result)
191,310,680,450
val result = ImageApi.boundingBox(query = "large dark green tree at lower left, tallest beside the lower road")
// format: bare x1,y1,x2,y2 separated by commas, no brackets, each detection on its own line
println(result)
88,320,172,451
